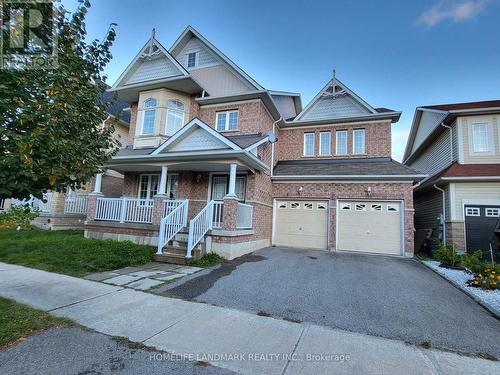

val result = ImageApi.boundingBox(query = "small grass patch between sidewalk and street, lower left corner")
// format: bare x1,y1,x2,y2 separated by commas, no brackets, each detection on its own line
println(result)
0,297,74,348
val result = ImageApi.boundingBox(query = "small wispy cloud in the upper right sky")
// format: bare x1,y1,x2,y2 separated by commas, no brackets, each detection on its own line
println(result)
417,0,486,27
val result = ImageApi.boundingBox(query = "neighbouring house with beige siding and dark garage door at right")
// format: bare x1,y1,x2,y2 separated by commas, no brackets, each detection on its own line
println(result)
403,100,500,257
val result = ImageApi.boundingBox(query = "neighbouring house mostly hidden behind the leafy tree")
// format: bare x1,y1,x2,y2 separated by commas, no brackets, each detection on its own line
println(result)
4,92,130,230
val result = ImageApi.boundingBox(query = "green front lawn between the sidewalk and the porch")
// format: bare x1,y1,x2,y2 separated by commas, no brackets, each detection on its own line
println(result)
0,230,155,276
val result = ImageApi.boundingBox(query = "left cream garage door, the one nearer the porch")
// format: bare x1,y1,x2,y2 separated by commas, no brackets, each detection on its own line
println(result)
274,201,328,249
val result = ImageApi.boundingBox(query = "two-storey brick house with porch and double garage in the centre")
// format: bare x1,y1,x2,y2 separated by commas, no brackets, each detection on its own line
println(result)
85,27,423,263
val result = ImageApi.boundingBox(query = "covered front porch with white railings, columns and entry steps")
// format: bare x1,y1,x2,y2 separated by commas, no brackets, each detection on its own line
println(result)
85,161,258,263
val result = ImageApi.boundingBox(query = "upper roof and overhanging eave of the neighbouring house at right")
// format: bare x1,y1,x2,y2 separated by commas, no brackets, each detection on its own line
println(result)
403,100,500,163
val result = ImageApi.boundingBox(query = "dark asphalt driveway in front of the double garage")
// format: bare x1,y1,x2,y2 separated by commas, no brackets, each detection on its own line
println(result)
165,247,500,358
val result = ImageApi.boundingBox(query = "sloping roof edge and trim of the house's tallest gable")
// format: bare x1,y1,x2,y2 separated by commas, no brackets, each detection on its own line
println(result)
169,26,264,90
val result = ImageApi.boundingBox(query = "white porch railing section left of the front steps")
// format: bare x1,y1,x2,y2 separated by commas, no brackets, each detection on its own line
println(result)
94,198,153,223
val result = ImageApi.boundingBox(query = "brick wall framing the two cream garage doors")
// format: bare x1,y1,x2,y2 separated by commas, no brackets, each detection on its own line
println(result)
273,183,414,253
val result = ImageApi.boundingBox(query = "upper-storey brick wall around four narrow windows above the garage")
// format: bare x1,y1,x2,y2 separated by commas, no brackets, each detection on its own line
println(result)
275,122,391,160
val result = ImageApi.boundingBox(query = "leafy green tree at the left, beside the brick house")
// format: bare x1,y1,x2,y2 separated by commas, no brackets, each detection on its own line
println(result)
0,0,118,199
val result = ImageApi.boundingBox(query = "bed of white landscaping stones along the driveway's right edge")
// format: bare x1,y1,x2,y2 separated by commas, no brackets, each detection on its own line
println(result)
424,260,500,314
